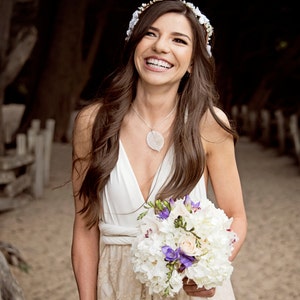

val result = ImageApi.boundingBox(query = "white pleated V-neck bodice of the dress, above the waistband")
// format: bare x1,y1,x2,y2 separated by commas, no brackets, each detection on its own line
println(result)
102,141,206,227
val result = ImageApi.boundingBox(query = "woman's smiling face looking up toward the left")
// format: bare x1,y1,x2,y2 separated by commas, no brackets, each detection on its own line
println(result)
134,13,193,88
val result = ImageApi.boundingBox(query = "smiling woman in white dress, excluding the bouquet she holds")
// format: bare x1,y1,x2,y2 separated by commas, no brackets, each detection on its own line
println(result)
72,0,246,300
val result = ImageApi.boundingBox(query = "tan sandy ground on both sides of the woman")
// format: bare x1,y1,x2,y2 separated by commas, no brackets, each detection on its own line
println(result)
0,137,300,300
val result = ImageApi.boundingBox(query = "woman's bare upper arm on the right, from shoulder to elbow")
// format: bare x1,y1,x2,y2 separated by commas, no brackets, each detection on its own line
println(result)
201,109,245,217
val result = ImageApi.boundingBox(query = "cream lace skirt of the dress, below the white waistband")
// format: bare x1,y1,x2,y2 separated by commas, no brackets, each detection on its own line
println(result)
98,245,235,300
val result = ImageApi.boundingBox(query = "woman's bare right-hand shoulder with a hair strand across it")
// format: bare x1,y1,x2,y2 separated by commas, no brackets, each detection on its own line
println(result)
200,107,231,143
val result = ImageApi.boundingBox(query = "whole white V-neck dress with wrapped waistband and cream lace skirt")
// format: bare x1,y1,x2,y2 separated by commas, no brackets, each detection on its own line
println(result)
98,141,235,300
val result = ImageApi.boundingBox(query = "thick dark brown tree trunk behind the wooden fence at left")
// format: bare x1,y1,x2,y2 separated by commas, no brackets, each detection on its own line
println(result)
20,0,111,141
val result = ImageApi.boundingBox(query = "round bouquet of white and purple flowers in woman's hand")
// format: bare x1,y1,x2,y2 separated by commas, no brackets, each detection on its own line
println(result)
131,195,237,297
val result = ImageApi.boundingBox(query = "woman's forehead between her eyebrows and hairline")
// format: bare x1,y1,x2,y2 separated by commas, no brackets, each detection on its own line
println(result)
152,13,192,37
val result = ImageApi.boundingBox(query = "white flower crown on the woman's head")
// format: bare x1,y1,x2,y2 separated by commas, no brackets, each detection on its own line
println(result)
126,0,213,56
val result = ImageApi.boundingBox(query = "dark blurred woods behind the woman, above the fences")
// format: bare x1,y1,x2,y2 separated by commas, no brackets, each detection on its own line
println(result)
0,0,300,148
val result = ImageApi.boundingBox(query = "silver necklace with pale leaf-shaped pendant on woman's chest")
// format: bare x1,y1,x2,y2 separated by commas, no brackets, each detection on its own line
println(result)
131,104,177,152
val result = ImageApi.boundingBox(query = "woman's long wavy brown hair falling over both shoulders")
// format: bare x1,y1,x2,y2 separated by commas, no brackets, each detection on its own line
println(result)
74,0,235,227
